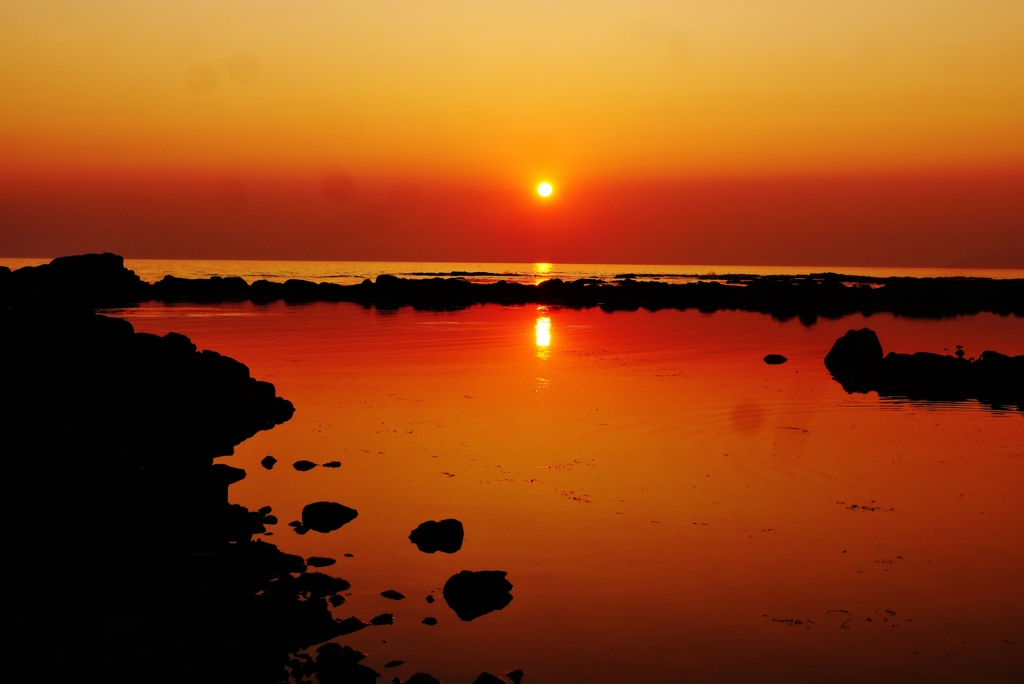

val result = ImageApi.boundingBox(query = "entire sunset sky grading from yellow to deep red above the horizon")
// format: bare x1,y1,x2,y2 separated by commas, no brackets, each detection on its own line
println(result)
0,0,1024,267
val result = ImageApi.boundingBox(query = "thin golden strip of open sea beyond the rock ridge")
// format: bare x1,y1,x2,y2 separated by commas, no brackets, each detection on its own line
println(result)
6,258,1024,285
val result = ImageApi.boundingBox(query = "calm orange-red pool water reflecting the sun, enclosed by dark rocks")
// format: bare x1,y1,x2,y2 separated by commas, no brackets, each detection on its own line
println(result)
112,301,1024,684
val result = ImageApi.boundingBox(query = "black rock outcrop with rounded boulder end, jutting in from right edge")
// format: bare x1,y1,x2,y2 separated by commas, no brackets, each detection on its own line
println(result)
825,328,1024,409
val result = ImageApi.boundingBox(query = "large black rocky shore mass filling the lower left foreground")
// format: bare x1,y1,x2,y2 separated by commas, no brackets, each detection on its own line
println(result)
0,307,373,684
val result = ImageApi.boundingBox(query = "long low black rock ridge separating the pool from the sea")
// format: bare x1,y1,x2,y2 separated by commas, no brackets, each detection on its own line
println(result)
8,254,1024,325
